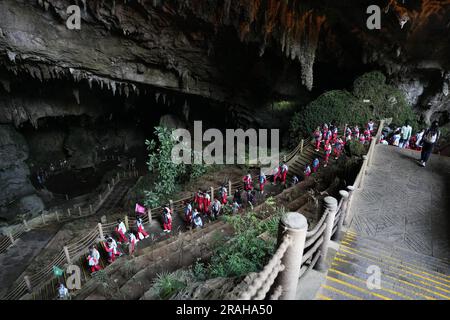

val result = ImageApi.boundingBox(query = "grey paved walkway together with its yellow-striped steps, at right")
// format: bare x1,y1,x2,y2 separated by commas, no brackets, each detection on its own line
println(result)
316,145,450,300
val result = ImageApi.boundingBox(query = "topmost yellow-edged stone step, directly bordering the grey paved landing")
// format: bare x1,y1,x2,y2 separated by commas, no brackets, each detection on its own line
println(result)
341,232,450,279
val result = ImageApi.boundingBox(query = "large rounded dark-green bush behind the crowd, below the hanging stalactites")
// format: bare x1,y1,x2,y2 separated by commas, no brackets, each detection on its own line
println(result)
290,71,417,140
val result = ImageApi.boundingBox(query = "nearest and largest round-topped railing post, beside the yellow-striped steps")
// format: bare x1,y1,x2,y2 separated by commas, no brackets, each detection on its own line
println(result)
274,212,308,300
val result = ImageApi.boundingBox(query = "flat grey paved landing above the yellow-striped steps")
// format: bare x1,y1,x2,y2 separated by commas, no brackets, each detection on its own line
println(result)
350,145,450,259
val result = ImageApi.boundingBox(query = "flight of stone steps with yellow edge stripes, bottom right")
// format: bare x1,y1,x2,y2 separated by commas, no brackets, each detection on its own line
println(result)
316,231,450,300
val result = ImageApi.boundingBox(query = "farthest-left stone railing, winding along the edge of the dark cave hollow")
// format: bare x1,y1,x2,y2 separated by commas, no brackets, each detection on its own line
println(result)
0,171,138,254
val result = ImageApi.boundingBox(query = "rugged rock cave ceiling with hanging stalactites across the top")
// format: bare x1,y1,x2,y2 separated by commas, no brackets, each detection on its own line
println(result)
0,0,450,121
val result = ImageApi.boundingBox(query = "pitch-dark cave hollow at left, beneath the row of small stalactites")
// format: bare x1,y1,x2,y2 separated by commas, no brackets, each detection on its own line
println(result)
9,73,236,198
